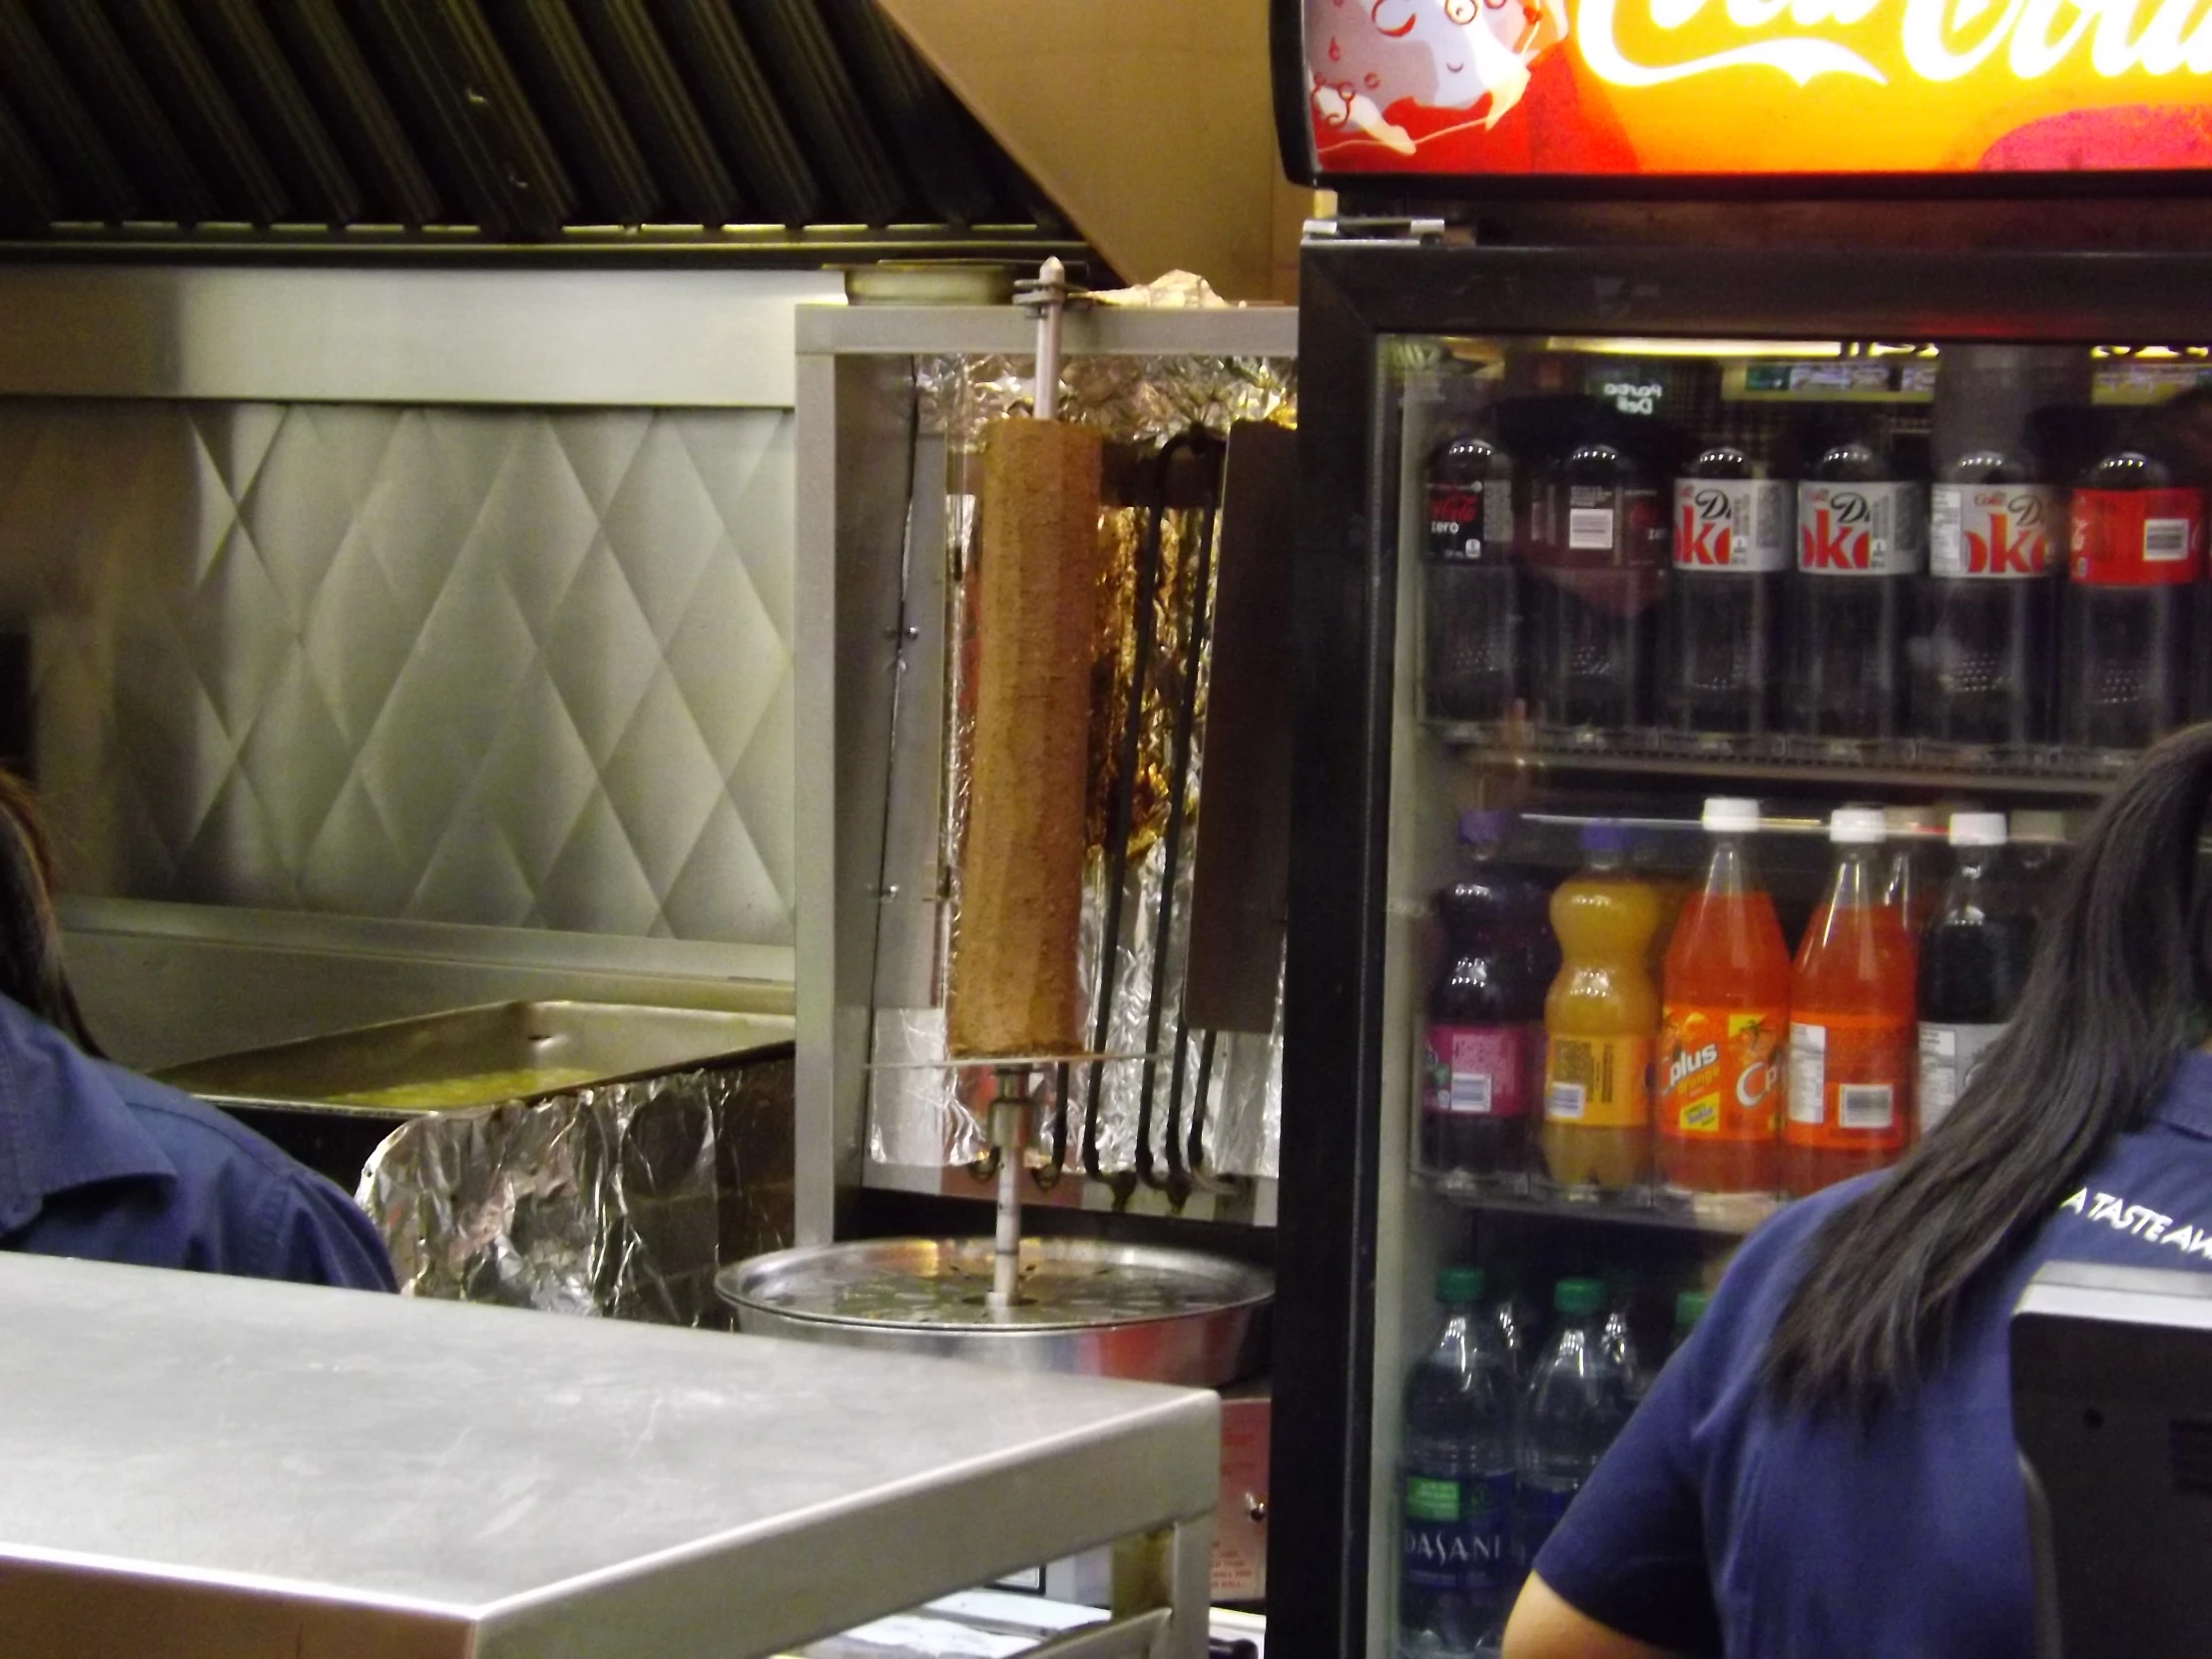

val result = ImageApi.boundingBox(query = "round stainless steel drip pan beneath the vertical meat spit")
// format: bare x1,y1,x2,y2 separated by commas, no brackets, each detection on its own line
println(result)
715,1239,1274,1386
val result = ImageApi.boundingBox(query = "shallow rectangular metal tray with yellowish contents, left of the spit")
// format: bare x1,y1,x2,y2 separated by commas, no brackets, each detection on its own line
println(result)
160,1002,792,1117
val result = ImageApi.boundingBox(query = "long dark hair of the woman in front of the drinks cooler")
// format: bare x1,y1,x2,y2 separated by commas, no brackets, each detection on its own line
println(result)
1765,726,2212,1417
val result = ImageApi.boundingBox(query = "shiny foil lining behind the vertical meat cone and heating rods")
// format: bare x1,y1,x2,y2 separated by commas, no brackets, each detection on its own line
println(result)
869,356,1297,1177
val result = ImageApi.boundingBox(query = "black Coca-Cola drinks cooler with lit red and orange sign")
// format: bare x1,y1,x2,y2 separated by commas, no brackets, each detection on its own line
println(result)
1270,0,2212,1659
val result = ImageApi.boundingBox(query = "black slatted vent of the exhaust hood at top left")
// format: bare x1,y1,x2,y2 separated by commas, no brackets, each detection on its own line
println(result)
0,0,1066,250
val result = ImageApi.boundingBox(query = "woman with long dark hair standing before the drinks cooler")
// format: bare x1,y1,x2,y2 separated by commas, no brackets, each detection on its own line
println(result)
1504,726,2212,1659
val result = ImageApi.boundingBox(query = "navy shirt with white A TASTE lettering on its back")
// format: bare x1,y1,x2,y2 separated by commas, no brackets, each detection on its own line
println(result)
1535,1053,2212,1659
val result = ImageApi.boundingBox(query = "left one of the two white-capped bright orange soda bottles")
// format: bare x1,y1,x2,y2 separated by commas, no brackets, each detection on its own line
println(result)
1657,799,1790,1192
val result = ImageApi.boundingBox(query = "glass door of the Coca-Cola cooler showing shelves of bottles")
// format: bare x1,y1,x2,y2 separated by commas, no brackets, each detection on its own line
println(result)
1354,329,2212,1655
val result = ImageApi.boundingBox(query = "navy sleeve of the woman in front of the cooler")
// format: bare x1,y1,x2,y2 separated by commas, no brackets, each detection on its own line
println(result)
1535,1328,1721,1655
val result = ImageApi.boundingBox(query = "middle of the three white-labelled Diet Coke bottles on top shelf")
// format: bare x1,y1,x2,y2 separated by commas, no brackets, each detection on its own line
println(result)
1790,422,1927,739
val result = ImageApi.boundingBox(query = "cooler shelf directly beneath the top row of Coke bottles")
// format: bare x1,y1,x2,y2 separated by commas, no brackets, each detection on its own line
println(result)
1422,721,2134,799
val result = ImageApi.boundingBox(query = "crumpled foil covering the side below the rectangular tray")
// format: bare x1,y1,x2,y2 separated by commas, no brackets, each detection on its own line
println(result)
358,1057,792,1328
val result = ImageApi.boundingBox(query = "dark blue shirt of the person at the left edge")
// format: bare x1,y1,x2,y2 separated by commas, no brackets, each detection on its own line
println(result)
0,997,393,1290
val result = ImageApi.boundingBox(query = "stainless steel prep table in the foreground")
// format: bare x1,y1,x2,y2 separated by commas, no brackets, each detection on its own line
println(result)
0,1252,1219,1659
